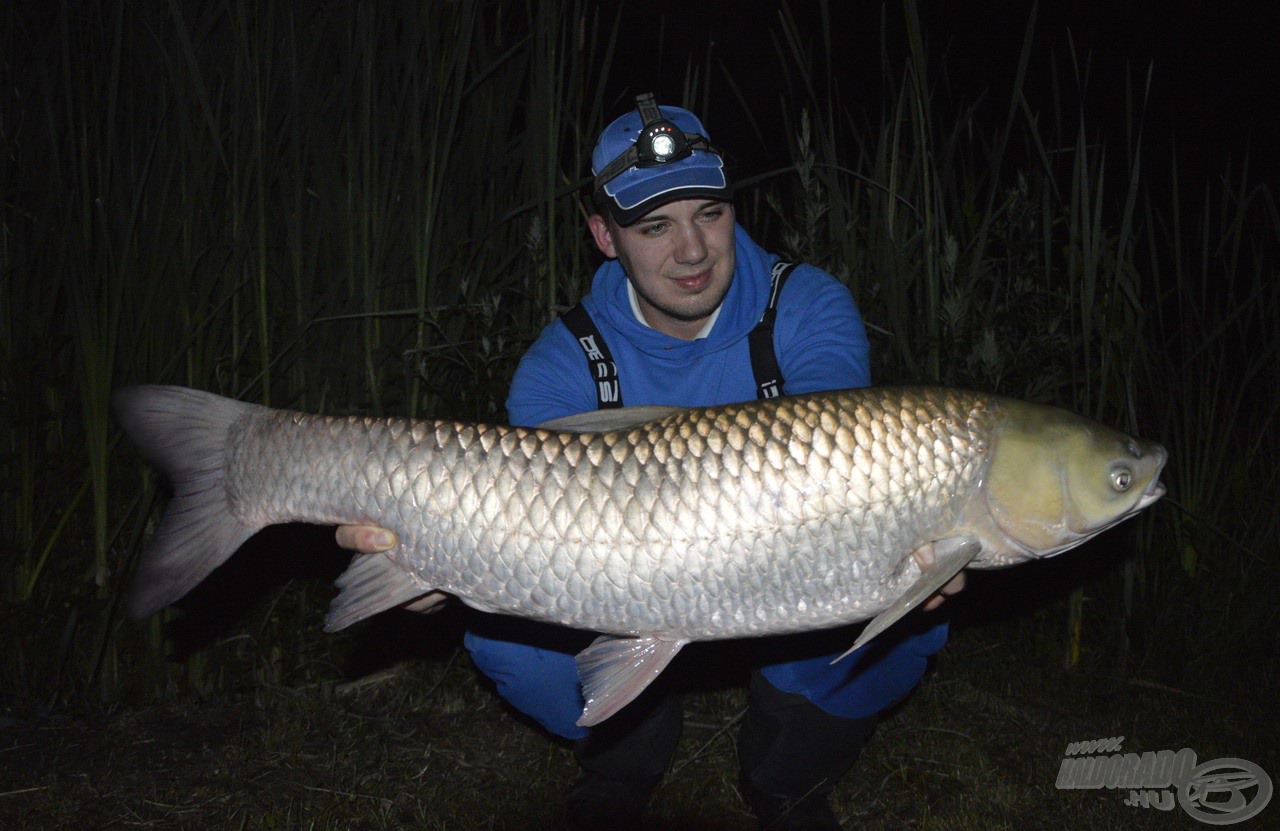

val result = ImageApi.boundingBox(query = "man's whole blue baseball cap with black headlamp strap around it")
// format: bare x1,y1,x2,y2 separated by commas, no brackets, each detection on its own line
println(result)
591,95,733,225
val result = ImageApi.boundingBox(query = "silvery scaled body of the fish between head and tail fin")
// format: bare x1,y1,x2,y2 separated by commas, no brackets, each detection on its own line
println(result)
217,393,980,638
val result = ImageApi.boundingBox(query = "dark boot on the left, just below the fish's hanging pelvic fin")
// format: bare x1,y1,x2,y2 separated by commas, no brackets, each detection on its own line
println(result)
564,695,684,831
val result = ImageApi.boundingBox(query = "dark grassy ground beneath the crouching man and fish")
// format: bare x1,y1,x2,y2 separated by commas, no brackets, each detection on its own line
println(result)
0,596,1280,831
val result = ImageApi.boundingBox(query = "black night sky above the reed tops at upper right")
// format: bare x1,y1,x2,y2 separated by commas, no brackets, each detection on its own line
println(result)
612,0,1280,188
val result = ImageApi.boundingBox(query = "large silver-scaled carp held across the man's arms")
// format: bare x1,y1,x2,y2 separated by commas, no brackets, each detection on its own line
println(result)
113,385,1167,726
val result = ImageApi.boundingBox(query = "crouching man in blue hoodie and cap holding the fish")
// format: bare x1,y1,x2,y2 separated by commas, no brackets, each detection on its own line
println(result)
339,96,960,828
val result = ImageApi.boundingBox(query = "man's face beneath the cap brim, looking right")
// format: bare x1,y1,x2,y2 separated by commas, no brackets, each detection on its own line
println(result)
588,198,735,341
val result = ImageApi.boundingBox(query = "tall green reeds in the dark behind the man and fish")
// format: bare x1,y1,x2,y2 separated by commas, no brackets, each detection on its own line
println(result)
0,0,1280,827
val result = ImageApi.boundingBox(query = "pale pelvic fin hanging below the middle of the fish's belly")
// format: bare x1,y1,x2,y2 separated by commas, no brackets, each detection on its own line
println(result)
576,635,689,727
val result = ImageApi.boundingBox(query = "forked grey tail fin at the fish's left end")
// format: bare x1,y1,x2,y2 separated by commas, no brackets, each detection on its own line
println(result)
111,385,259,617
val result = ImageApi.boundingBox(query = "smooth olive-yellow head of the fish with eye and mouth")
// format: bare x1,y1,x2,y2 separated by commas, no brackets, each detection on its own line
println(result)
973,401,1167,567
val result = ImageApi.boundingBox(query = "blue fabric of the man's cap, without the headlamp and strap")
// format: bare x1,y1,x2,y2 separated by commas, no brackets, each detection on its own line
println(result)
591,106,733,225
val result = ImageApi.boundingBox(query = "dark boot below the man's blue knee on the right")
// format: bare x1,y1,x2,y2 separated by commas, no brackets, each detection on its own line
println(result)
737,672,876,831
